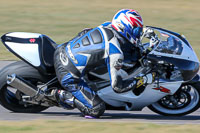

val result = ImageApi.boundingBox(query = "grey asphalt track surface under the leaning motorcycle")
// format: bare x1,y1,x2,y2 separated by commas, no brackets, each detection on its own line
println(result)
0,61,200,124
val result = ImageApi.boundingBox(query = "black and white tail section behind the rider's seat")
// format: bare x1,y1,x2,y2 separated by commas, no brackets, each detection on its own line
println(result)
1,32,56,72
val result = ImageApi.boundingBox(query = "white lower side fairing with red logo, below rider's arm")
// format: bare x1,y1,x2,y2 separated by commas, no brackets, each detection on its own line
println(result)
98,82,182,110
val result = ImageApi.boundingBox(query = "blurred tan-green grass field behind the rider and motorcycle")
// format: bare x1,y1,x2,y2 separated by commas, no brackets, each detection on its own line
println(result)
0,0,200,60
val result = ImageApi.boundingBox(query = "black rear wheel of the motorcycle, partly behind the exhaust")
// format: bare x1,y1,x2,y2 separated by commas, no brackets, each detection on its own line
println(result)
0,61,48,113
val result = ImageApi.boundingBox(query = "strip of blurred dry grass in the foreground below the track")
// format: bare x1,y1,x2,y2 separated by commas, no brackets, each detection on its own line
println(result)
0,120,200,133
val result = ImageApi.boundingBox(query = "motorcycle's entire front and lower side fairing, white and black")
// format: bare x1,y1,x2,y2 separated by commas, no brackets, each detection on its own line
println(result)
98,27,199,110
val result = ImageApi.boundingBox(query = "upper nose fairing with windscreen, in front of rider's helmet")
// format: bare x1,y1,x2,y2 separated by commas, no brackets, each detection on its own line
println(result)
148,27,199,81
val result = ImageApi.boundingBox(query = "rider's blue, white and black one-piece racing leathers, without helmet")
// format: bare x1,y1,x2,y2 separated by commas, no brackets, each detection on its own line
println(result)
54,22,149,117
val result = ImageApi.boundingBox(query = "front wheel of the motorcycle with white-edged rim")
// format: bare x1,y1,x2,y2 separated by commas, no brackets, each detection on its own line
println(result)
149,82,200,116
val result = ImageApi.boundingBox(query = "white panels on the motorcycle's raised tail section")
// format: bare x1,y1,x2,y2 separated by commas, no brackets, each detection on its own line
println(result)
5,32,41,67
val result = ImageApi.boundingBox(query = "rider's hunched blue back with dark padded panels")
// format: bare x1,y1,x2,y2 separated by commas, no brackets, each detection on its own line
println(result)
66,22,117,72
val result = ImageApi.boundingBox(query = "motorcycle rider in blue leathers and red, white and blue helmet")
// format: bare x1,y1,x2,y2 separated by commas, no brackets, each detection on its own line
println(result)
54,9,155,117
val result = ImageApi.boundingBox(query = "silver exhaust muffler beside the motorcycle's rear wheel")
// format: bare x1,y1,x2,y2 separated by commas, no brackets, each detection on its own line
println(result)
7,74,44,101
